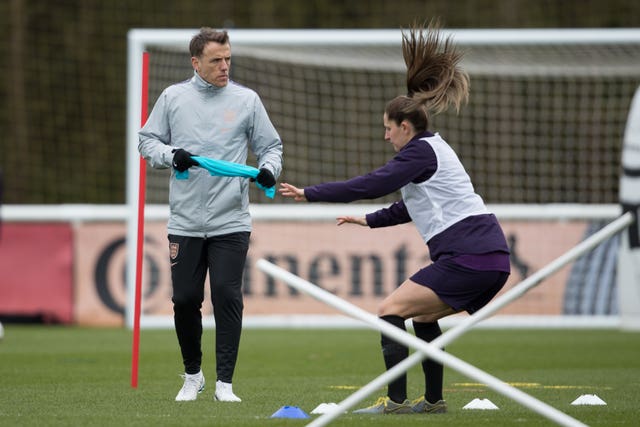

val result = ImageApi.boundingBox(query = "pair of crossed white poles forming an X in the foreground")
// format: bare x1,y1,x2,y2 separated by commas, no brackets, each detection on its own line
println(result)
257,212,634,427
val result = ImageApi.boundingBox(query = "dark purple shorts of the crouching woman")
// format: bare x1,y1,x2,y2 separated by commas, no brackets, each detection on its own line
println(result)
410,259,509,314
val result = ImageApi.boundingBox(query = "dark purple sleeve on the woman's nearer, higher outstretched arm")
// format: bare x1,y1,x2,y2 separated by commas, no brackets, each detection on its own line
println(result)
304,140,437,203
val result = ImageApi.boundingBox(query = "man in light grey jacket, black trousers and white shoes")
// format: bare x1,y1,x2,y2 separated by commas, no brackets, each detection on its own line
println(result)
138,28,282,402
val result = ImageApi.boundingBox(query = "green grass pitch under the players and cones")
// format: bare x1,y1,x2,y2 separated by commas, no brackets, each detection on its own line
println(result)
0,324,640,427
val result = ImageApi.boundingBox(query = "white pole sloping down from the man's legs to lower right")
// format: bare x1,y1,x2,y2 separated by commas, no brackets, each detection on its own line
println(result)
256,259,584,427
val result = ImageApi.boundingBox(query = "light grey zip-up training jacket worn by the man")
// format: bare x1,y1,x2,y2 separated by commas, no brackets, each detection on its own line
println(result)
138,72,282,237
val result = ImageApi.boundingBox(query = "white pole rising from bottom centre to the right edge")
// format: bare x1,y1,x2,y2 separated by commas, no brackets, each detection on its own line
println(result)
312,212,634,424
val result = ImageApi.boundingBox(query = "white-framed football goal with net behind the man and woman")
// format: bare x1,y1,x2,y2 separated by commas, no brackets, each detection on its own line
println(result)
127,30,640,332
